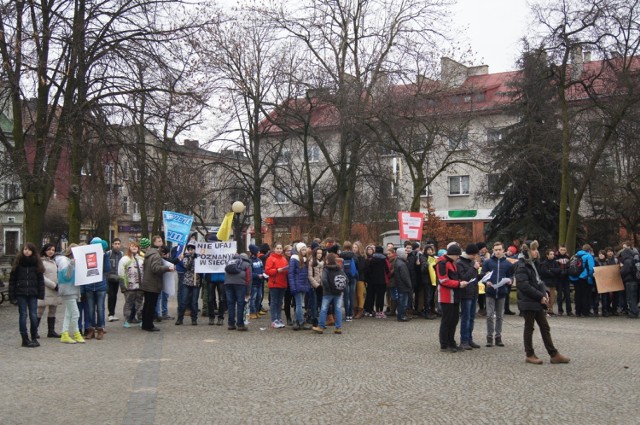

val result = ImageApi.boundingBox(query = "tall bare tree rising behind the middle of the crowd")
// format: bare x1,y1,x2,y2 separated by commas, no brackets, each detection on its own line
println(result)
263,0,447,239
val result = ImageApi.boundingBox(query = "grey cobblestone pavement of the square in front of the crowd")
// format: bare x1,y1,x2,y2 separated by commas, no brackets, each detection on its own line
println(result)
0,297,640,425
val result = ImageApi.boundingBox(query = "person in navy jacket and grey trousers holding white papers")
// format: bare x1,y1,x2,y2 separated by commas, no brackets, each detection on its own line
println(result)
480,242,513,347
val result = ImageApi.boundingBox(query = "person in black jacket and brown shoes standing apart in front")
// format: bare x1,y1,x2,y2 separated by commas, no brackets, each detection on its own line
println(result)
515,241,569,365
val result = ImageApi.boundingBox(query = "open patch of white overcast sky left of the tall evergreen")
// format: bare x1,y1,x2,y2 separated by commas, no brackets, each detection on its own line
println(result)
452,0,530,73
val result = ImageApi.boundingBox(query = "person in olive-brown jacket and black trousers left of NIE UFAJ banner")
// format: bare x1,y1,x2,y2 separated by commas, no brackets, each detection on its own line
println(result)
140,245,174,332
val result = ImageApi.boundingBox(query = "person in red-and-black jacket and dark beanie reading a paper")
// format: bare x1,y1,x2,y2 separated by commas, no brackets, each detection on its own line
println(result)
436,244,468,353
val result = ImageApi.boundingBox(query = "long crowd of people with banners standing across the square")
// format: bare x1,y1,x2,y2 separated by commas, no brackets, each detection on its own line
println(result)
9,236,640,364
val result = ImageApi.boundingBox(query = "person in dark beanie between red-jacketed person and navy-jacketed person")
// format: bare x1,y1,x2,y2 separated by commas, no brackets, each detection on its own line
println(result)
456,244,480,350
